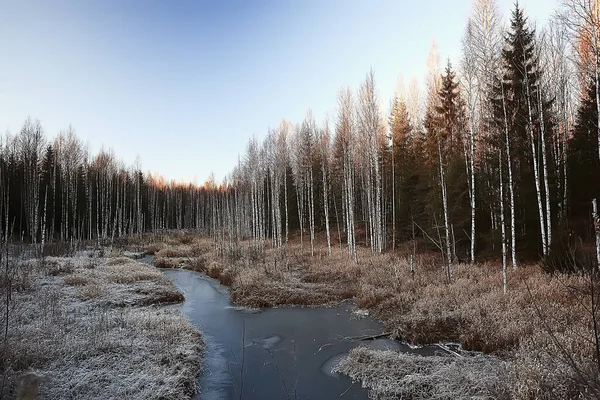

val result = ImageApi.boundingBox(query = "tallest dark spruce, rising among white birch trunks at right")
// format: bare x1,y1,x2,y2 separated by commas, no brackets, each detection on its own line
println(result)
488,4,553,254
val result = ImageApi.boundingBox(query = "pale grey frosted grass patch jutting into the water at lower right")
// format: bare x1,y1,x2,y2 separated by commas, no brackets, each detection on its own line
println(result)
334,347,509,400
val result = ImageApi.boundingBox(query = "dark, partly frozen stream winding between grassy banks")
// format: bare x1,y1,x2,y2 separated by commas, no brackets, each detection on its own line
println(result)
164,269,442,400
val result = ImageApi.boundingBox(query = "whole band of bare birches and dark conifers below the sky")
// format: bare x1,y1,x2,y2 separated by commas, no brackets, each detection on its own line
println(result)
0,0,600,274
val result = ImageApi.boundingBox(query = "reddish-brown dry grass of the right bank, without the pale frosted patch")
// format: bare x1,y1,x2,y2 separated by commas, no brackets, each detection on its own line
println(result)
139,235,600,399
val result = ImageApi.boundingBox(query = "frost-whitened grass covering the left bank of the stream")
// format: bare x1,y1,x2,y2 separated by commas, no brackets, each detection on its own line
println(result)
0,250,204,399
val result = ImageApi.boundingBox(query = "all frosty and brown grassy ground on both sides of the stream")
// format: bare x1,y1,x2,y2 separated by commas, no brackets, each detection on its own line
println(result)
2,231,598,399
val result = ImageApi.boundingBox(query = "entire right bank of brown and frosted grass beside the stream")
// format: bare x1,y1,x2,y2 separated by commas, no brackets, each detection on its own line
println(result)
146,233,598,399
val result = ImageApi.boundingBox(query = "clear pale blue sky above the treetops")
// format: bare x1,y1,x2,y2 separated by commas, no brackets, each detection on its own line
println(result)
0,0,558,183
